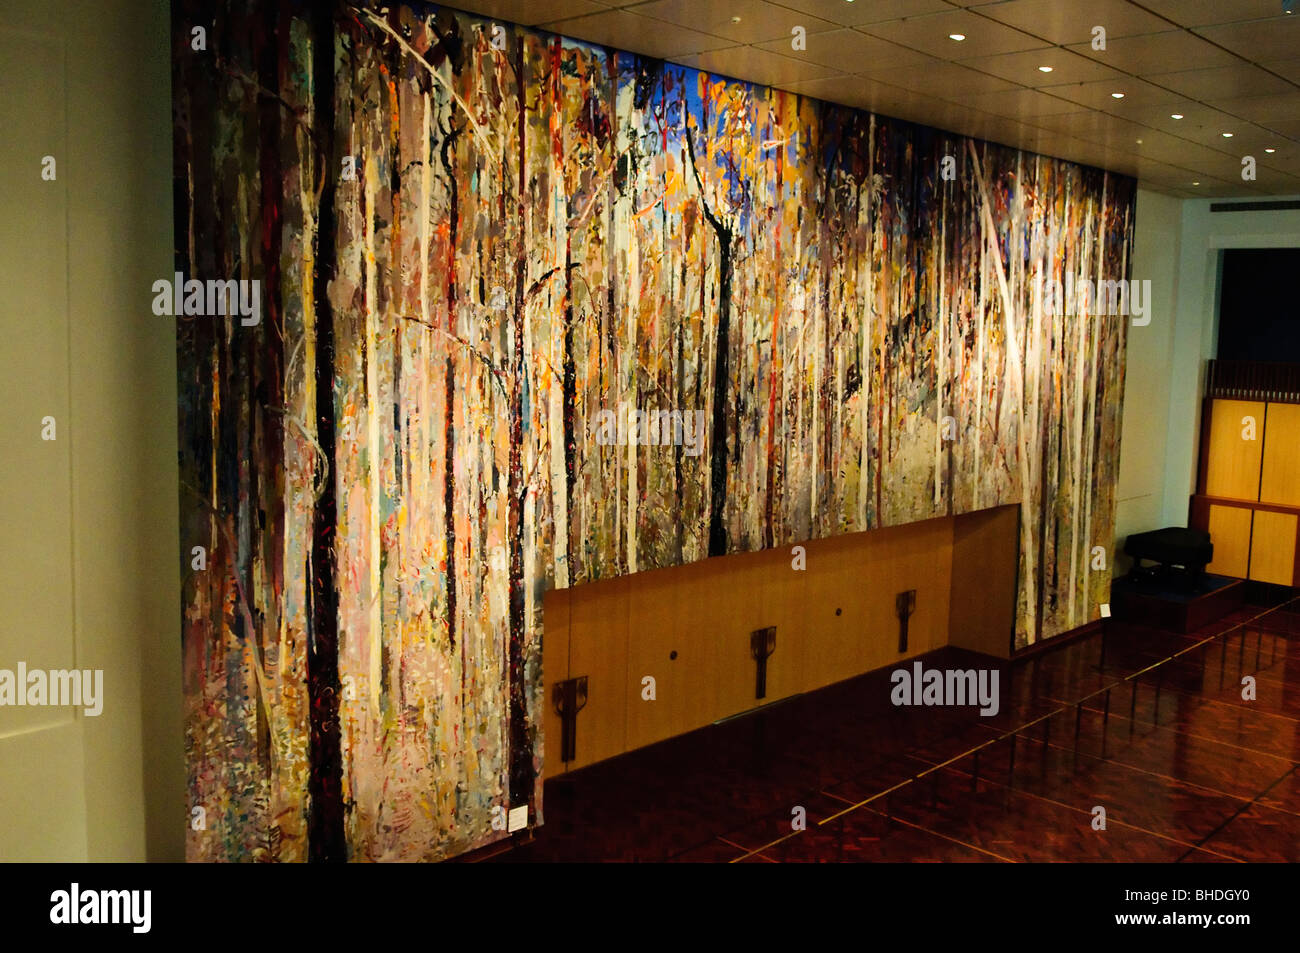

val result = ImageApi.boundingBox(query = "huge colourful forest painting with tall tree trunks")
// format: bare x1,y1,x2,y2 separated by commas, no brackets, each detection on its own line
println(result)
173,0,1135,861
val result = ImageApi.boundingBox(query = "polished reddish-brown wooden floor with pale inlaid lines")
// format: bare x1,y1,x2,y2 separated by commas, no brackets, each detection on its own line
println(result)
464,590,1300,863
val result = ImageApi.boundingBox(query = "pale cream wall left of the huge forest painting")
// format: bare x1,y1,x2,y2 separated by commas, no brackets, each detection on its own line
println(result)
0,0,180,861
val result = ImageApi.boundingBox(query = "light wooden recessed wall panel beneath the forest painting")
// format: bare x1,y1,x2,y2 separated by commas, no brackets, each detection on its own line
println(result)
542,506,1019,776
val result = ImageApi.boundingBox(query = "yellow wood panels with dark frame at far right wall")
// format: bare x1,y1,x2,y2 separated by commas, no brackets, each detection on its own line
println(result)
1190,398,1300,585
